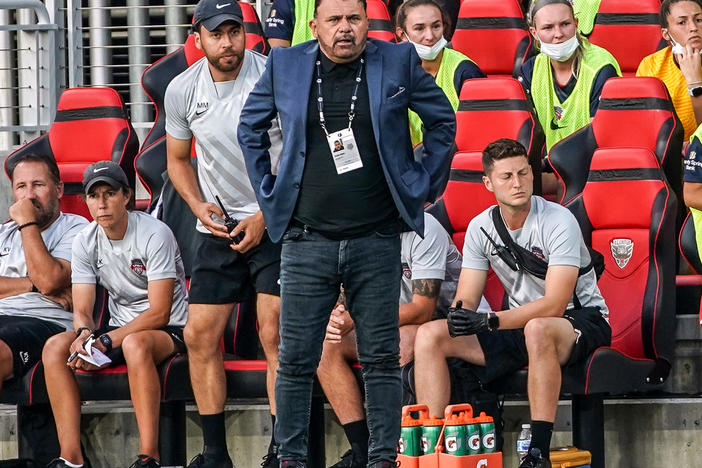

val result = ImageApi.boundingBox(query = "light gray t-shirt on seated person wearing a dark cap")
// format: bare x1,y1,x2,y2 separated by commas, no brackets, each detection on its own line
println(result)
72,211,188,327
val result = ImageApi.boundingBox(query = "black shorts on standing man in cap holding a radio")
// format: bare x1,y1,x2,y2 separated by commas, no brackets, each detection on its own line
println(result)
189,232,280,304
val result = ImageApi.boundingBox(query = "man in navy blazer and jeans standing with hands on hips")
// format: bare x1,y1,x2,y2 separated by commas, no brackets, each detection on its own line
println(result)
238,0,456,468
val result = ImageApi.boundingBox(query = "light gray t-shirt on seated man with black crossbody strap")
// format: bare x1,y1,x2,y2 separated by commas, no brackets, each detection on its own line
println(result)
463,196,609,319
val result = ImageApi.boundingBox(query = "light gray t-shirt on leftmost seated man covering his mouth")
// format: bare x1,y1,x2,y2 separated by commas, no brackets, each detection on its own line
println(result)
0,213,88,330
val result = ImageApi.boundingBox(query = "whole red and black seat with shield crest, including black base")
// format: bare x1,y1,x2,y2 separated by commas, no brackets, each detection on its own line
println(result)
493,148,677,468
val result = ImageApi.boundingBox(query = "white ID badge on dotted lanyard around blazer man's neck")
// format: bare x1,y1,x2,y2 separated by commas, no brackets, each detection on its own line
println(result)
316,59,365,174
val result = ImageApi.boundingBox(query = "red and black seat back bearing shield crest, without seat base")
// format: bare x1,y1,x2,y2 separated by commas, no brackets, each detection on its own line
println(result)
568,148,677,362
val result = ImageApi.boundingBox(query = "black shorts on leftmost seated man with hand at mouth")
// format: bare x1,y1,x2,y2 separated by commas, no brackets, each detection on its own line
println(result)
0,315,66,377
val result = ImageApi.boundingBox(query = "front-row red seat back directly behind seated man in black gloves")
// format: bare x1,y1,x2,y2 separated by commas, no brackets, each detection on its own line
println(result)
427,151,505,310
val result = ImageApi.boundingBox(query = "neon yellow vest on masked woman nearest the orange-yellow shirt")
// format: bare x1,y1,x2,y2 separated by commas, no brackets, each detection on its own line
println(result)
531,42,622,150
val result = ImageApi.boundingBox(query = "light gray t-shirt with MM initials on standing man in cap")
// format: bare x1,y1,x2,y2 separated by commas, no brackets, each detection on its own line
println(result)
165,49,282,232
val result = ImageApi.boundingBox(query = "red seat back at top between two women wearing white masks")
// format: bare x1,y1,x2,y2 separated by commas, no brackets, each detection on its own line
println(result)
452,0,531,78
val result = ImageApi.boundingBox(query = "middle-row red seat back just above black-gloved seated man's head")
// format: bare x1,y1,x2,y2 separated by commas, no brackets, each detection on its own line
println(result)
456,77,544,194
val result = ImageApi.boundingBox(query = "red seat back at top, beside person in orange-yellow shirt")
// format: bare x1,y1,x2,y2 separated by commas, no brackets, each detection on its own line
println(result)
589,0,662,76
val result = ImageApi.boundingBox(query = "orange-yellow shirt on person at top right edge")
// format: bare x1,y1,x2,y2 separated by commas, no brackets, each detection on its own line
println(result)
636,46,697,140
